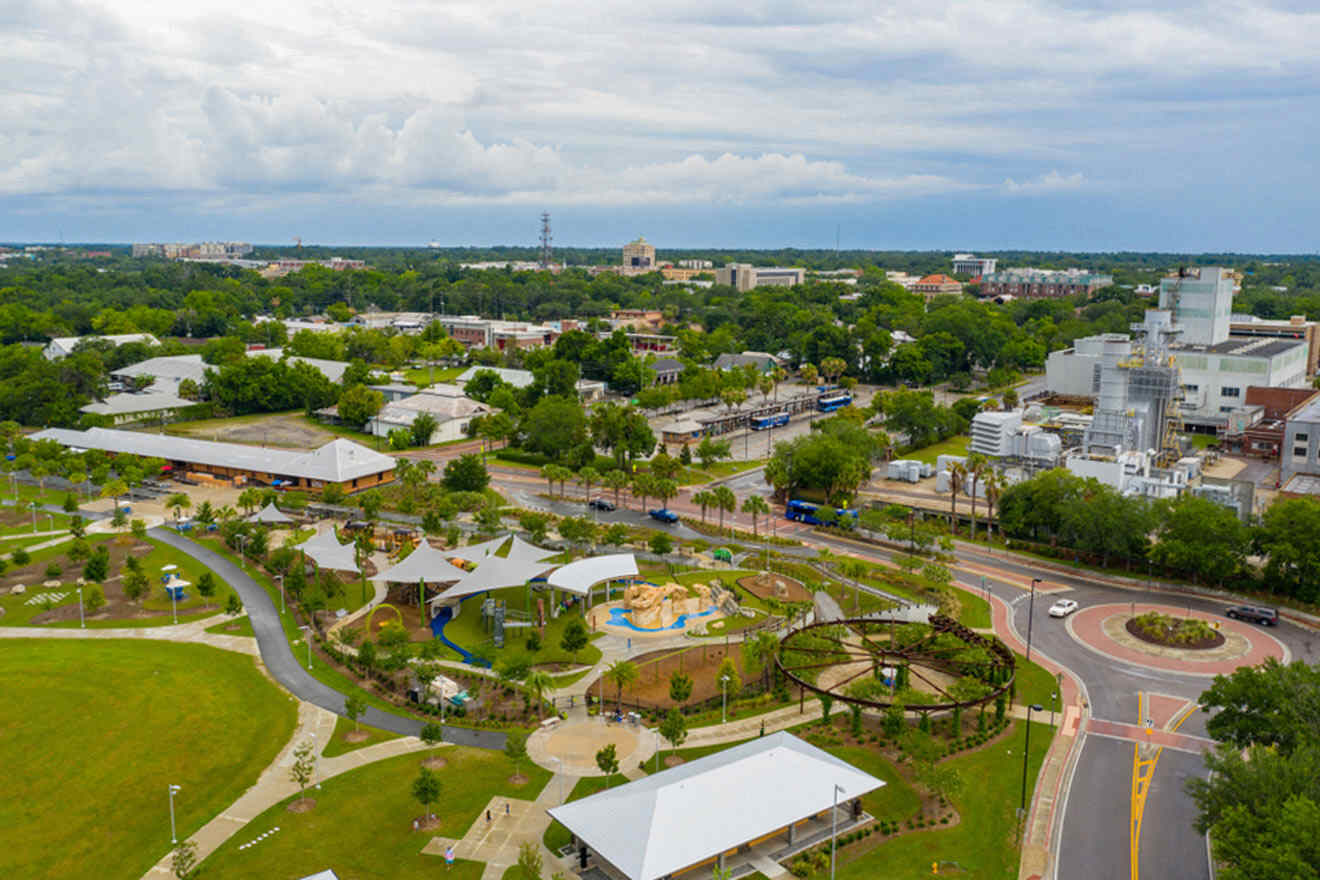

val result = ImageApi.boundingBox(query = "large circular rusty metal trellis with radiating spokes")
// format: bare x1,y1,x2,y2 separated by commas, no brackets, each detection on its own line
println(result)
775,615,1016,712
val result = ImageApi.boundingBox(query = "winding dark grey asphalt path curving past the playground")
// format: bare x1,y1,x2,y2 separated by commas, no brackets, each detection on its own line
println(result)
148,528,504,749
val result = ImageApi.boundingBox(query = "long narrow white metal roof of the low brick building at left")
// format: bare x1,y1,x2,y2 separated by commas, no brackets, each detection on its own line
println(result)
33,427,395,483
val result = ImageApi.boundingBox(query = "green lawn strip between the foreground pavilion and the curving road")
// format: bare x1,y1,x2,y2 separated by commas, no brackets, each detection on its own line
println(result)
838,723,1049,880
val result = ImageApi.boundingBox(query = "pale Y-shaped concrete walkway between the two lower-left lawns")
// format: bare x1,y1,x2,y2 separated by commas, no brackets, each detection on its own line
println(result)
143,703,428,880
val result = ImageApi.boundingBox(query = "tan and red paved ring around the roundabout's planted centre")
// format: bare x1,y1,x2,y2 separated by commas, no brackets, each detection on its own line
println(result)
1067,602,1290,678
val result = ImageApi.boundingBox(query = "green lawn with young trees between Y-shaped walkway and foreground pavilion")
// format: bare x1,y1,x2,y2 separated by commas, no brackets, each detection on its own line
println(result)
199,747,550,880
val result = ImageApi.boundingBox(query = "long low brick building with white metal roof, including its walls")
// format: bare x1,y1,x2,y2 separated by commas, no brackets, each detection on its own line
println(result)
32,427,395,492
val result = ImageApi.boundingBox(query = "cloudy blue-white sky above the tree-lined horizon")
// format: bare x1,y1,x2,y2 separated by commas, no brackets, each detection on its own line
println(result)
0,0,1320,250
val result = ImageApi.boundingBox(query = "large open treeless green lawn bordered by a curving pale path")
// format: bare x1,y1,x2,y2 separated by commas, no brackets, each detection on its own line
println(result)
0,639,297,880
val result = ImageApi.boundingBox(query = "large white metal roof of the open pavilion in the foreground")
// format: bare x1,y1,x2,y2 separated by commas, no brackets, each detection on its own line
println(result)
546,731,884,880
